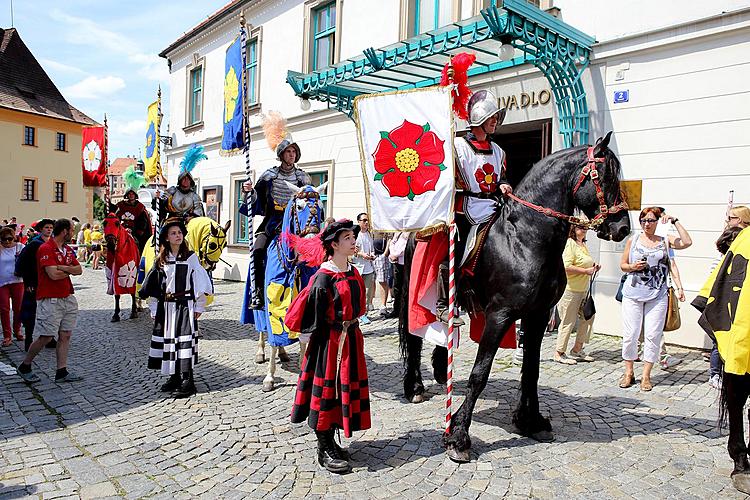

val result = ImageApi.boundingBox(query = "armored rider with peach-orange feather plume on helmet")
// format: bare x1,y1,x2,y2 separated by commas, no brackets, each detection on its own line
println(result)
240,112,312,309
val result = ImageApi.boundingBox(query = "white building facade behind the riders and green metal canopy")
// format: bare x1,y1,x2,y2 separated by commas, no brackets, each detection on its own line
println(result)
162,0,750,347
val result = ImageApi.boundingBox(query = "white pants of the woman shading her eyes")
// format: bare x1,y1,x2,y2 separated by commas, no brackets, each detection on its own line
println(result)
622,294,669,363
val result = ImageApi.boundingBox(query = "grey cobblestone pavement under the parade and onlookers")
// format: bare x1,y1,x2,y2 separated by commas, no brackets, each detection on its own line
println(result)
0,269,740,499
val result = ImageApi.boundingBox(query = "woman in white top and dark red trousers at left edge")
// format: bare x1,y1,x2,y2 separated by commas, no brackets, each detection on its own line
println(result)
0,226,24,347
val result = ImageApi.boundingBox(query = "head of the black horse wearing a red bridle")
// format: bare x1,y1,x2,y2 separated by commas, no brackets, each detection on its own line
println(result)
571,132,630,241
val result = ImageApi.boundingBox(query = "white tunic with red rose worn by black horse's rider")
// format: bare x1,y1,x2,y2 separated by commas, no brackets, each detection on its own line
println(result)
453,137,507,224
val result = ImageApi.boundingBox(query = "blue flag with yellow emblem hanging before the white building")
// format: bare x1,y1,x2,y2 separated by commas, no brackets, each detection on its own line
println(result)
219,37,245,156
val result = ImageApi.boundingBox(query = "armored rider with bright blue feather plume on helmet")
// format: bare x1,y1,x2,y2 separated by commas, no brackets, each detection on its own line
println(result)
159,144,208,223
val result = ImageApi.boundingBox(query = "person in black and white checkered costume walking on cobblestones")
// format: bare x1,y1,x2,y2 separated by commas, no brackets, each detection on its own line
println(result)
140,217,213,398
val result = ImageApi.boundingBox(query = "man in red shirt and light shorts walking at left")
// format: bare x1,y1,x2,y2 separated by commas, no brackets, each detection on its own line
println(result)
17,219,83,383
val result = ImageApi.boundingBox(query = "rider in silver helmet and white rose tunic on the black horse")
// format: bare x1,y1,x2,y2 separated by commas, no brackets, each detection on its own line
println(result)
436,90,513,326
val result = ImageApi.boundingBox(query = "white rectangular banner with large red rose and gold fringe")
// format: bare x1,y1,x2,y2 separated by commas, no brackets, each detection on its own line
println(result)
354,87,455,231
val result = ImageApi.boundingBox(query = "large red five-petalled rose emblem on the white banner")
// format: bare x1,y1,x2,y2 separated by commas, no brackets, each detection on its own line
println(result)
372,120,446,200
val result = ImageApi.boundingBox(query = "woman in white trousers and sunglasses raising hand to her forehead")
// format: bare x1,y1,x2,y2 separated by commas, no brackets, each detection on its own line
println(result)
620,207,685,391
